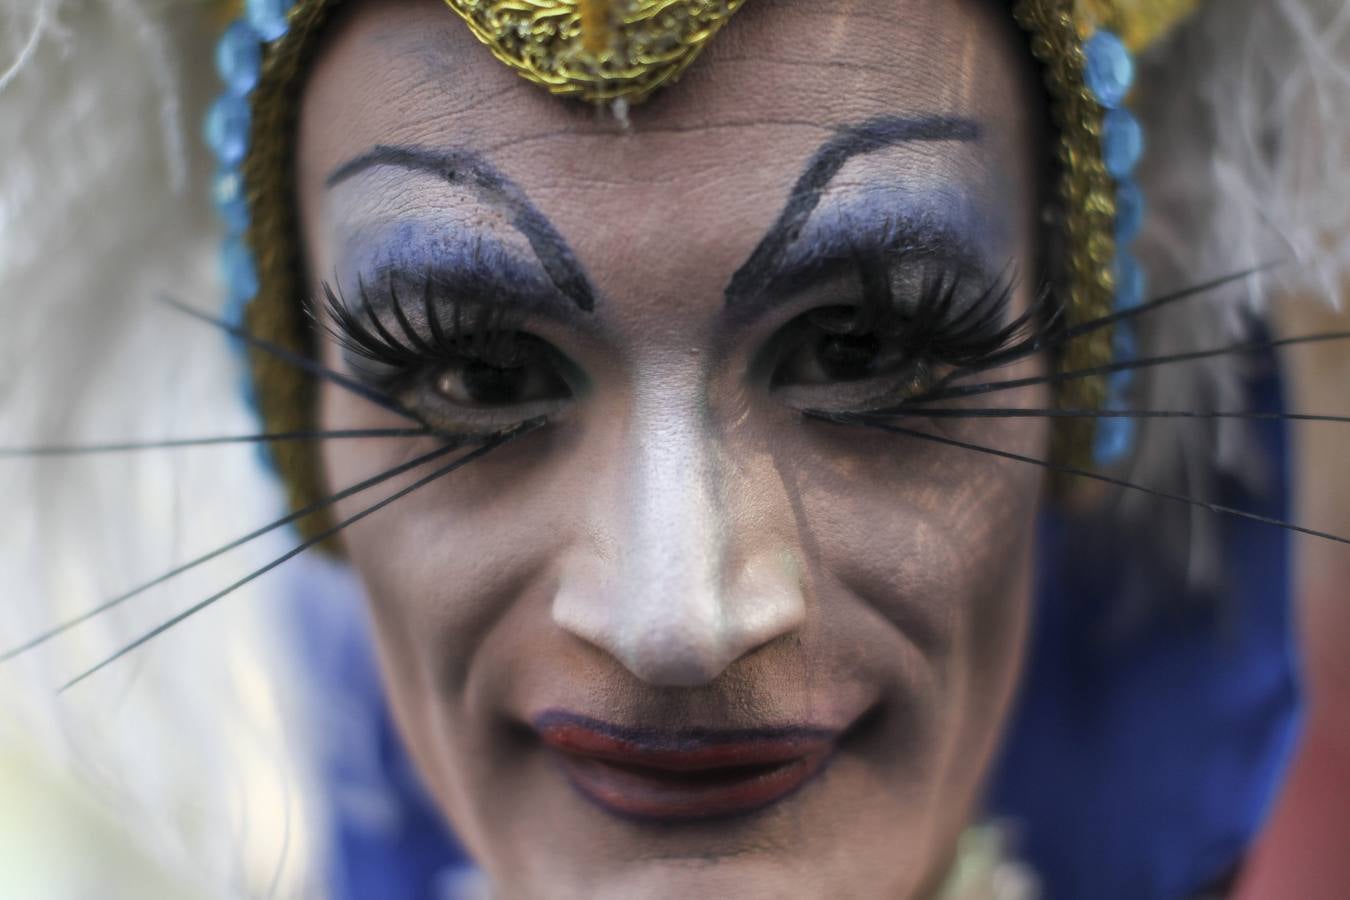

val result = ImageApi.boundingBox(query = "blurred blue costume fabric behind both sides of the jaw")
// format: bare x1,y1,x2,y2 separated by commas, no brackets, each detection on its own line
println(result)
297,360,1299,900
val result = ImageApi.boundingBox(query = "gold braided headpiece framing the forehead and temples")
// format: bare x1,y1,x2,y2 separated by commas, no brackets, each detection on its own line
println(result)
224,0,1199,533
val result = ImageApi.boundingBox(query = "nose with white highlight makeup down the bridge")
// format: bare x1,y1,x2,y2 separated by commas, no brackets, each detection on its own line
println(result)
552,377,806,687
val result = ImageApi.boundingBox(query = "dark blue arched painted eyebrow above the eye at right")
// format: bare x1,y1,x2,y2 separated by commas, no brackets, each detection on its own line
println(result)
725,116,980,321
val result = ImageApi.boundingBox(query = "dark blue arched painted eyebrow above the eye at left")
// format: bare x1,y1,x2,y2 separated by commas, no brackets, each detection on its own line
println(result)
324,144,595,312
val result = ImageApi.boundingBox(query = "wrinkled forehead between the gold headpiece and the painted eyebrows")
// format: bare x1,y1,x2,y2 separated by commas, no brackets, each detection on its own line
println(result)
298,0,1037,323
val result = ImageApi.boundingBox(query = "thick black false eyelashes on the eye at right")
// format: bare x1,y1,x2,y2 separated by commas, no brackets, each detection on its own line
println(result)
813,249,1060,381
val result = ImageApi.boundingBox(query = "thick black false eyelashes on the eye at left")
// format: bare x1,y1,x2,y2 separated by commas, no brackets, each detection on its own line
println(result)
306,269,532,378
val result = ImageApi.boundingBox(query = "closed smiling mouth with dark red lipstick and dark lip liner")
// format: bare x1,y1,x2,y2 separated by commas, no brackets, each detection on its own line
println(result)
533,710,840,823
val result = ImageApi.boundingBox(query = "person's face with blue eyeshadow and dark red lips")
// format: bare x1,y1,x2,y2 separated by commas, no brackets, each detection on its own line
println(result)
298,0,1046,897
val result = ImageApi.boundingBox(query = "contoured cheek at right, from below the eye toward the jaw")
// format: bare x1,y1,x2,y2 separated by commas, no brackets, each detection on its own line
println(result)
791,407,1046,723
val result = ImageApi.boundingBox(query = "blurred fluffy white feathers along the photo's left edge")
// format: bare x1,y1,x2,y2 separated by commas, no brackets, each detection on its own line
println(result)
0,0,321,896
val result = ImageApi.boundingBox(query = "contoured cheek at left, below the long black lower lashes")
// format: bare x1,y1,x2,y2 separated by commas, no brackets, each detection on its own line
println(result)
321,372,583,674
